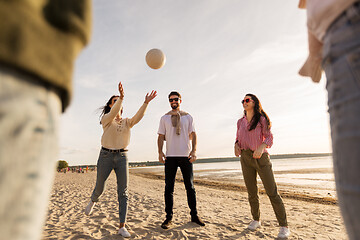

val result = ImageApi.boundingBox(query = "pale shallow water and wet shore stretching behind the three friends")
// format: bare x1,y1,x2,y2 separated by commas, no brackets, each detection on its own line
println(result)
130,157,337,205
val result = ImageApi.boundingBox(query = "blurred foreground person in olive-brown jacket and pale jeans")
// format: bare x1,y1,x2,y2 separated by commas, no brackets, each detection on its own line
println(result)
0,0,91,240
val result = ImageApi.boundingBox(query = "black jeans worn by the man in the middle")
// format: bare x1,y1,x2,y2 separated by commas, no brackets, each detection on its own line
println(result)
165,157,197,219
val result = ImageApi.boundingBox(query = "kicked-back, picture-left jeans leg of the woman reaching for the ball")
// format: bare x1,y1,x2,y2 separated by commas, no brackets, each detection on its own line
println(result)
91,150,116,202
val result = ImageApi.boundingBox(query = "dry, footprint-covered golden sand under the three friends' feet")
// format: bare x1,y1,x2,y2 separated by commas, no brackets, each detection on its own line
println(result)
42,171,347,240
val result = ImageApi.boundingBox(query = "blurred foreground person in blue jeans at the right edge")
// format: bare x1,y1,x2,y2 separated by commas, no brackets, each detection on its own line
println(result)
299,0,360,240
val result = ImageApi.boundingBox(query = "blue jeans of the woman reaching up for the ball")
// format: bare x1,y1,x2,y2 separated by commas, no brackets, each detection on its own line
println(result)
91,149,129,223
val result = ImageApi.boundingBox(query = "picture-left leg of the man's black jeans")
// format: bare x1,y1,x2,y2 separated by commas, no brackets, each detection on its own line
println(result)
164,157,178,219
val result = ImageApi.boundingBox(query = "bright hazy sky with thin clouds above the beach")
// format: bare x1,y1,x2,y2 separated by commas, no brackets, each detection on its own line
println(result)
60,0,331,165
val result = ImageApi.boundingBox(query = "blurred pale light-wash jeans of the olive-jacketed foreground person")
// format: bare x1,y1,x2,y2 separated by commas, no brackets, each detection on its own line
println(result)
0,66,61,240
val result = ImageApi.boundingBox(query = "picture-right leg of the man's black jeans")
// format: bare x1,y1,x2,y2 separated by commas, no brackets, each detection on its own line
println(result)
179,157,197,216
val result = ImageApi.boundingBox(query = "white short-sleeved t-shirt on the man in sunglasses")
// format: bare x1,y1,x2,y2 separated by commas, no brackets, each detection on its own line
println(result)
158,114,195,157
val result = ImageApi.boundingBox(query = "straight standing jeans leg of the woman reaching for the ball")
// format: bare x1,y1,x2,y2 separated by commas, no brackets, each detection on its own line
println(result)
114,152,129,223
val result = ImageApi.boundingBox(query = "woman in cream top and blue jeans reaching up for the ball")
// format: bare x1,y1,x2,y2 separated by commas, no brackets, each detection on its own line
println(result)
85,82,157,237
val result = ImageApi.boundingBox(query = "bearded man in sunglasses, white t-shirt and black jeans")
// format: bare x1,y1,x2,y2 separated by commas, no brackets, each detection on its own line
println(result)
158,92,205,229
